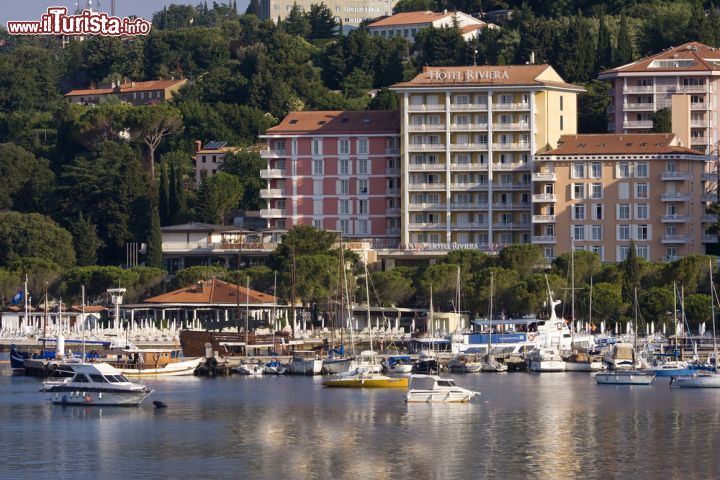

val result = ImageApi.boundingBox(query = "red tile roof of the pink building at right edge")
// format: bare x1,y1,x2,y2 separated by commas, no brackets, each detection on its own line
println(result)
600,42,720,78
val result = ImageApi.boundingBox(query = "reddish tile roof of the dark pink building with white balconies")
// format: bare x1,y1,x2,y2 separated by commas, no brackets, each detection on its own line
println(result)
265,110,400,135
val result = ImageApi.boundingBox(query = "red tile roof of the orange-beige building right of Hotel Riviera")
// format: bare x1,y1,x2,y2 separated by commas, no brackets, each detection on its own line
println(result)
540,133,705,157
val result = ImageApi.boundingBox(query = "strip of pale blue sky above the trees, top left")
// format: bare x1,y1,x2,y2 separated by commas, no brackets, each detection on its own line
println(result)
0,0,249,27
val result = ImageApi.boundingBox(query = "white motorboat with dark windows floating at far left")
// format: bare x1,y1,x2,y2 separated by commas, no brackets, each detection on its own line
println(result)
41,362,152,406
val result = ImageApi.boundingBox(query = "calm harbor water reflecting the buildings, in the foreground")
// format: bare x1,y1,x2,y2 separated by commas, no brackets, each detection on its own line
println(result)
0,355,720,479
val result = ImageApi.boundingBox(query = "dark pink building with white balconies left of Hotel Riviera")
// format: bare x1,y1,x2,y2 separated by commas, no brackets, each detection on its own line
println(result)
260,111,400,247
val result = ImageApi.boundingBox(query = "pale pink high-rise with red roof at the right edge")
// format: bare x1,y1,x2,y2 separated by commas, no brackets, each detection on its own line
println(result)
599,42,720,154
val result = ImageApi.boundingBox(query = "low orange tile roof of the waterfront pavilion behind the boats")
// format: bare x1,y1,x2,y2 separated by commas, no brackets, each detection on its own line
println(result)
145,278,276,305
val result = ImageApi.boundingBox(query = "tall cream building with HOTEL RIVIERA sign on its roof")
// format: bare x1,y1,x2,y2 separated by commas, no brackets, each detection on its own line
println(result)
392,65,583,251
